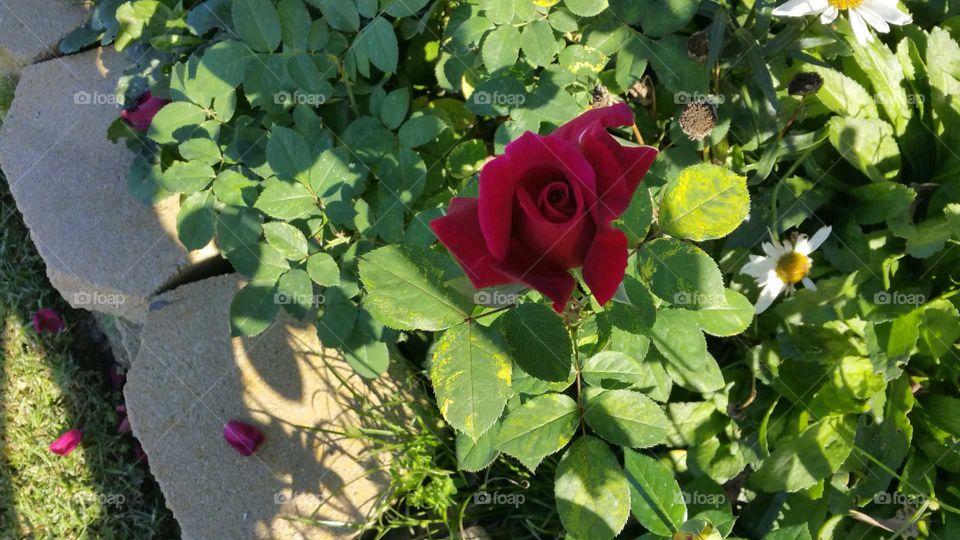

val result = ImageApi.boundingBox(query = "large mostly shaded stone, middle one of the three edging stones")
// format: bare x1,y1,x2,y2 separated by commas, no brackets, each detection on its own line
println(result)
0,50,215,322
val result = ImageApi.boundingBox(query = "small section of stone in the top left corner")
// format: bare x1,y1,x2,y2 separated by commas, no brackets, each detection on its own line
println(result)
0,0,90,75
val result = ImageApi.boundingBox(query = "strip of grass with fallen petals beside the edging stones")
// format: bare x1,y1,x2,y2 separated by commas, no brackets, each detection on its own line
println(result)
0,168,179,539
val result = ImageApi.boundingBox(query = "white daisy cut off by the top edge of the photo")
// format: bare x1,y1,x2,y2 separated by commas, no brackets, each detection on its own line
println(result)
773,0,913,45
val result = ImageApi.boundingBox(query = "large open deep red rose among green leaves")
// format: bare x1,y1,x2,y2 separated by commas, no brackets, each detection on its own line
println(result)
430,103,657,312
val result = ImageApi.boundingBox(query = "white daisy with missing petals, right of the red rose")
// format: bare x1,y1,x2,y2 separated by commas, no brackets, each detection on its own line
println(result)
740,227,833,314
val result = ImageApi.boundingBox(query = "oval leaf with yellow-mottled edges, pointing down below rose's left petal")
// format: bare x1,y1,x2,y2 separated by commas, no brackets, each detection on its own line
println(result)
432,322,512,441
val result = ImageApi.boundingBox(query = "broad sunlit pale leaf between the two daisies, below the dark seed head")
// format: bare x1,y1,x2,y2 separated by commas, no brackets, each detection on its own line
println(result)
828,116,900,182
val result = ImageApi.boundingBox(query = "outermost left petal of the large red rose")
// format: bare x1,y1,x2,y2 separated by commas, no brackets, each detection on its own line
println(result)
430,197,512,289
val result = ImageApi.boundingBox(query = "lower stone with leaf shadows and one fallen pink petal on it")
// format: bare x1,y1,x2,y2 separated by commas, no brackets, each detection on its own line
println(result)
124,275,413,539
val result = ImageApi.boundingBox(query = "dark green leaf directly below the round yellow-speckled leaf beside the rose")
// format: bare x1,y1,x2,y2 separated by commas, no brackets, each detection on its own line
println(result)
637,238,726,309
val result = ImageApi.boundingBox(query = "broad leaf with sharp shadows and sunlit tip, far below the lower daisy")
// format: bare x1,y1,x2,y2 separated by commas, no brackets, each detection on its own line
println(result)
750,416,857,493
